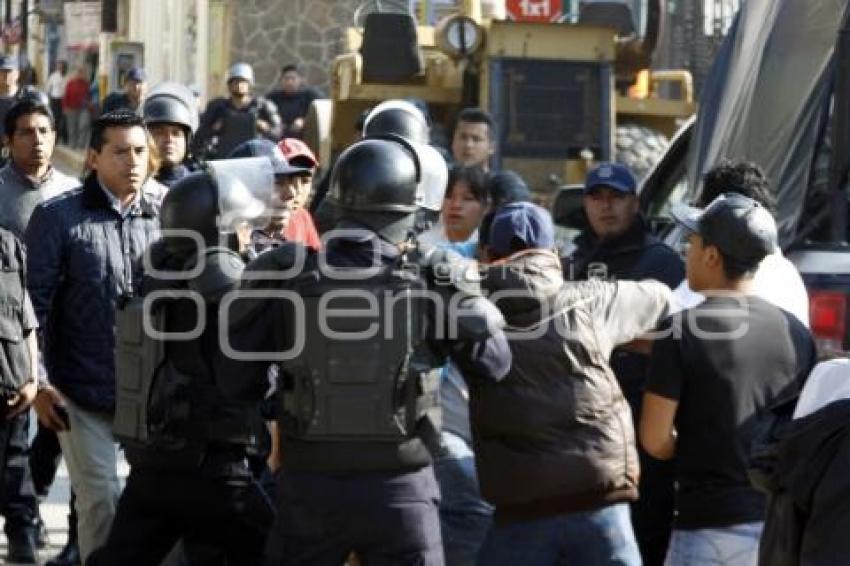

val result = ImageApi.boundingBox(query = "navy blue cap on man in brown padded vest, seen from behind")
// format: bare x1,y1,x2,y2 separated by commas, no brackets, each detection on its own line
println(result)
488,202,555,257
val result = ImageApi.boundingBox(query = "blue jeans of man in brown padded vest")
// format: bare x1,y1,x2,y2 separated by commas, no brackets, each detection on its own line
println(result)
478,503,641,566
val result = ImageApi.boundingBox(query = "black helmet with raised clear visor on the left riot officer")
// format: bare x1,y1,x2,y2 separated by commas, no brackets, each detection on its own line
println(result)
160,157,274,257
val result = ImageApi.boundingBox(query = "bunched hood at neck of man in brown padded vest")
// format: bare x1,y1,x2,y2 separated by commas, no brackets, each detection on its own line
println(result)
482,250,564,317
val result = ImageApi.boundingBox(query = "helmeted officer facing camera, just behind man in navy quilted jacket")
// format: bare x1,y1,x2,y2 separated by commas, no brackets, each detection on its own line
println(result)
142,82,199,188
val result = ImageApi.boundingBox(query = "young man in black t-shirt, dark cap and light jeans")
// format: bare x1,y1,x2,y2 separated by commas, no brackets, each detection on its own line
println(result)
640,194,815,566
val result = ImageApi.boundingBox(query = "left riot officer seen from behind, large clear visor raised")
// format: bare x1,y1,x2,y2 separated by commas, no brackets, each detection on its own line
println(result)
88,157,273,566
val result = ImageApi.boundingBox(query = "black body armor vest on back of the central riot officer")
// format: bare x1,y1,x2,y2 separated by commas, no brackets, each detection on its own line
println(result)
280,265,442,450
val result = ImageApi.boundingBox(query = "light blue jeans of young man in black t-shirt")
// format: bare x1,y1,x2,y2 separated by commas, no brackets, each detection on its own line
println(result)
664,522,764,566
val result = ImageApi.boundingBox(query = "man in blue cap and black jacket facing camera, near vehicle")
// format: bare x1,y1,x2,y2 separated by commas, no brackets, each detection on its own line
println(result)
564,163,685,566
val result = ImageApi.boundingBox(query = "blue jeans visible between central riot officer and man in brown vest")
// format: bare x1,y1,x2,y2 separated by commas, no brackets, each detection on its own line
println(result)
434,431,493,566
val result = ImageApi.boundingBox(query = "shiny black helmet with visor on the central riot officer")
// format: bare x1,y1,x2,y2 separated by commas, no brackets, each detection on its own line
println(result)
329,136,448,243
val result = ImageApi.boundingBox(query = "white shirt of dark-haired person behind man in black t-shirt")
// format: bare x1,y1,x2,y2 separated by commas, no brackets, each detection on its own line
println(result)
673,250,809,328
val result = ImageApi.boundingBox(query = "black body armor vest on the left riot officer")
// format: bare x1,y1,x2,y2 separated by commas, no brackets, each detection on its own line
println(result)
113,250,258,468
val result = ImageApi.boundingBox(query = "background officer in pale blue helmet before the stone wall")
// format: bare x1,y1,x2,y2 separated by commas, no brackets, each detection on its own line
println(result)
192,63,282,159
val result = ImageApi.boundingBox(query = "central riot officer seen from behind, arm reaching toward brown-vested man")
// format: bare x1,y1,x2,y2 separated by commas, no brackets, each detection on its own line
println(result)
219,132,510,565
